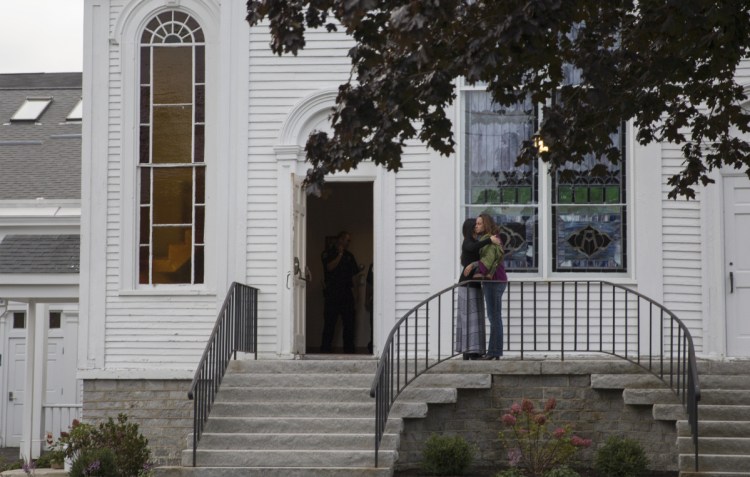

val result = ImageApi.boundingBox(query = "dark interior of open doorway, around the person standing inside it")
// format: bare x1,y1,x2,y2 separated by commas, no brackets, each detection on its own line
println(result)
305,182,374,354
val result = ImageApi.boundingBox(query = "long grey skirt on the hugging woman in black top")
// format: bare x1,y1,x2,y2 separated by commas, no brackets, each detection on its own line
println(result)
454,286,486,354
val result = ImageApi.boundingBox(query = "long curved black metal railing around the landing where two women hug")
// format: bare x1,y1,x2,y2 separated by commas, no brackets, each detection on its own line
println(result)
370,281,700,471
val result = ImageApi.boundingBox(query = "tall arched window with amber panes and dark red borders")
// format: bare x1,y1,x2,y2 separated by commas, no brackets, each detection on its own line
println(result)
138,11,206,285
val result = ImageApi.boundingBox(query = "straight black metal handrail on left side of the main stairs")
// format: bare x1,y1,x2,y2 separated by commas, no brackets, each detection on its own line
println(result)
188,282,258,467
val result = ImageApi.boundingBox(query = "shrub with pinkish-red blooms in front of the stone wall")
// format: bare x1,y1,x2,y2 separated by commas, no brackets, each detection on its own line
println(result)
500,398,591,477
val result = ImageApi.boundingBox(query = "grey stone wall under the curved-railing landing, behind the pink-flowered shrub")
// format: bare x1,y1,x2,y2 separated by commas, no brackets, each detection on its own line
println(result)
396,374,677,471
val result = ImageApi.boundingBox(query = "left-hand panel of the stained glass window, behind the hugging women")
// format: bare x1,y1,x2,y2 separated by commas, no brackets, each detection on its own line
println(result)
464,91,539,272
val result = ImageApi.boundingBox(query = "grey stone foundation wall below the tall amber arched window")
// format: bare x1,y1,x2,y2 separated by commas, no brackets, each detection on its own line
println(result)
83,379,193,465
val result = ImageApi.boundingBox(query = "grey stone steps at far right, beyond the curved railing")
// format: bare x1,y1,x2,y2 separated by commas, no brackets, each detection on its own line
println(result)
591,361,750,477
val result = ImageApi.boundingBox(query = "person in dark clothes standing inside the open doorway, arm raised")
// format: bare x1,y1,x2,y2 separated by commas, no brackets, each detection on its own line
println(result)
320,231,360,353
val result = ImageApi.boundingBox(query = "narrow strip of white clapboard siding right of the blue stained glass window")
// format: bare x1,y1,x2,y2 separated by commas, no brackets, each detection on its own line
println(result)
662,144,704,352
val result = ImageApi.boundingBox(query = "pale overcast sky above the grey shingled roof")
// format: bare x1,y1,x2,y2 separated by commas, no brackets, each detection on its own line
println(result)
0,0,83,73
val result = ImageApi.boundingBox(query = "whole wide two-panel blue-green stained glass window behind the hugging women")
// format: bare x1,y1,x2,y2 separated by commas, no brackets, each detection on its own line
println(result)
462,84,628,274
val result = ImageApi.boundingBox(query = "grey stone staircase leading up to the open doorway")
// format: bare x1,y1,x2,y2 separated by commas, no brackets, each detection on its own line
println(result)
157,359,491,477
